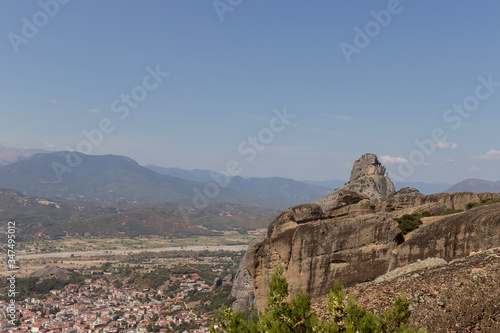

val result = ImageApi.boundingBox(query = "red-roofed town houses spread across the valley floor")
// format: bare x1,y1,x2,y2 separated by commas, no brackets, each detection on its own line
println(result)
0,276,218,333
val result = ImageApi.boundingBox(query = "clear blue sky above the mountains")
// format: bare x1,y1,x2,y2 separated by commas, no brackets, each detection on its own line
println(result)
0,0,500,182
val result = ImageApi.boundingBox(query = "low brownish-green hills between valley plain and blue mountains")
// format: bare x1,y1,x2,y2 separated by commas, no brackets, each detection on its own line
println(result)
0,189,278,239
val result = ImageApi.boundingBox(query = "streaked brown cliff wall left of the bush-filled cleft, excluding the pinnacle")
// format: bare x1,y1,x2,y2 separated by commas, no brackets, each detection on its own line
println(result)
247,208,403,309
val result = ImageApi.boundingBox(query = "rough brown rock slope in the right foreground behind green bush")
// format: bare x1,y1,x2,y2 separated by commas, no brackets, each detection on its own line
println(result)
312,248,500,333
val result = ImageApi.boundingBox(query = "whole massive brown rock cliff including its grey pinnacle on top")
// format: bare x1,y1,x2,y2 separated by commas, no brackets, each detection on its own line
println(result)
236,154,500,310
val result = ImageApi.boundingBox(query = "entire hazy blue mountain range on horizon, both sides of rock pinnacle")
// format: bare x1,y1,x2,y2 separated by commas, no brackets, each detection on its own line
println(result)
0,146,500,214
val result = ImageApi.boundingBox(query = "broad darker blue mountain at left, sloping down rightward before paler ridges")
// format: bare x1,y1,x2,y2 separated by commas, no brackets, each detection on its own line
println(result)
0,152,287,209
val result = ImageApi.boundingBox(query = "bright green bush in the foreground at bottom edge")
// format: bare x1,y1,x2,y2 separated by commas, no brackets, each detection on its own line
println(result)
210,265,425,333
